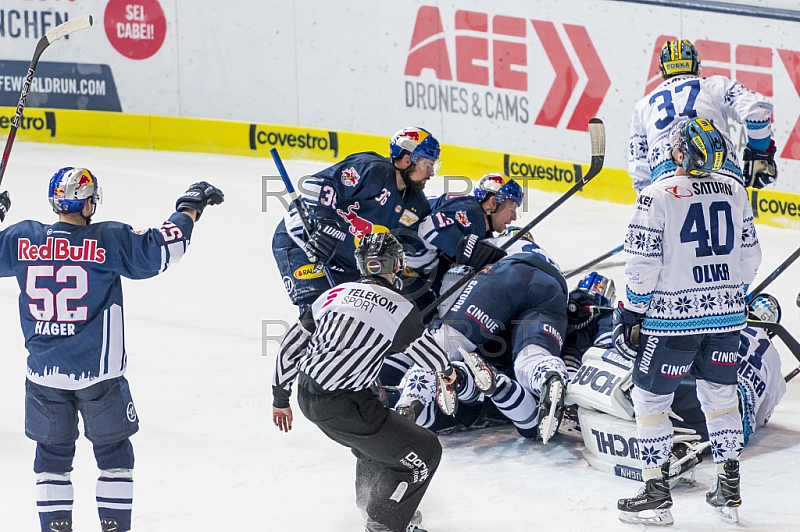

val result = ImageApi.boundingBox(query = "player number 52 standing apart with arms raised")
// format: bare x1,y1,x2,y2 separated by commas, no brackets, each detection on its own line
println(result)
0,171,224,532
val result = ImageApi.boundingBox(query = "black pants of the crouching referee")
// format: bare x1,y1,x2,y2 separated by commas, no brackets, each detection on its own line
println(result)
297,380,442,532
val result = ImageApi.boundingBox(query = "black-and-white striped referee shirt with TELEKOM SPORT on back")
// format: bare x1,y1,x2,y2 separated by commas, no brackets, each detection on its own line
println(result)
272,277,450,408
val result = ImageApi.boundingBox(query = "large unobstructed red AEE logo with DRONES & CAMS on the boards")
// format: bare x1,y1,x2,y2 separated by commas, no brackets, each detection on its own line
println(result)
405,6,611,131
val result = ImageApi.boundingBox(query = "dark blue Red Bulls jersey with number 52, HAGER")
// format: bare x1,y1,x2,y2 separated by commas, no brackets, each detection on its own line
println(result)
0,212,194,390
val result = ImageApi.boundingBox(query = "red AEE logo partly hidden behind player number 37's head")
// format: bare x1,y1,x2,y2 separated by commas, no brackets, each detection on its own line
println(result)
644,35,800,160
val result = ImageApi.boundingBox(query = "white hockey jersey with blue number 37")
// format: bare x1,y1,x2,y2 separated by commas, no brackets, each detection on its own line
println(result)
628,74,772,190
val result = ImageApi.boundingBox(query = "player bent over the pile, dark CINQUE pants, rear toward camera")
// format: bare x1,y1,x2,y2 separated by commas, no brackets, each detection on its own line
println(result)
398,228,567,443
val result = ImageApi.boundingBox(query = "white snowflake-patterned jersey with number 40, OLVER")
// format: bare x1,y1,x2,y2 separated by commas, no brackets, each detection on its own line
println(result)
624,174,761,336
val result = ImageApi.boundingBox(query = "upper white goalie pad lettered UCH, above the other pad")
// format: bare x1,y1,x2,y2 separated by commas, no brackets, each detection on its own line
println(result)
566,347,635,426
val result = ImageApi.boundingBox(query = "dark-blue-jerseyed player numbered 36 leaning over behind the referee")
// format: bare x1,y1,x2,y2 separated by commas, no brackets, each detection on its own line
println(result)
272,127,440,311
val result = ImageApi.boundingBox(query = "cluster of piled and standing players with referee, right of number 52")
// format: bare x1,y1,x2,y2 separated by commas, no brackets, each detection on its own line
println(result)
273,41,785,532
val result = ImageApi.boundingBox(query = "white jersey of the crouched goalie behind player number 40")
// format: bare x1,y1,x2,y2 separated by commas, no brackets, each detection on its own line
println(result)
738,327,786,443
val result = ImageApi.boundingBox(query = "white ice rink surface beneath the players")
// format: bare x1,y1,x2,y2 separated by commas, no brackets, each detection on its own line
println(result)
0,142,800,532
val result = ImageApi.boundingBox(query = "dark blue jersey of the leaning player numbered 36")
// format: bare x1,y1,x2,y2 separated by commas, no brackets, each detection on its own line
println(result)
276,152,430,272
